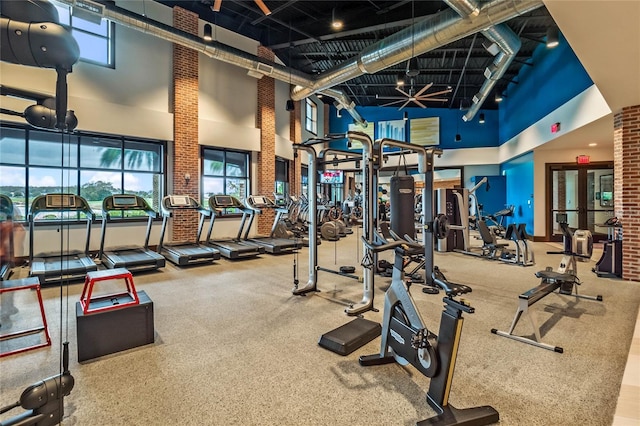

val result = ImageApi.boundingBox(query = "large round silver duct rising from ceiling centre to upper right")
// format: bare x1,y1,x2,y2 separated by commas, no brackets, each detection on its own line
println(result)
291,0,543,100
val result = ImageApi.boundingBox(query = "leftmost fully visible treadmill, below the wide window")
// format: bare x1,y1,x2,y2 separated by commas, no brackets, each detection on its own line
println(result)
29,194,98,285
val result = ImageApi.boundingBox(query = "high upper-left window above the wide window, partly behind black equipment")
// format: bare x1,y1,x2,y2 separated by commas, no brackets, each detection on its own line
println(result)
55,4,115,68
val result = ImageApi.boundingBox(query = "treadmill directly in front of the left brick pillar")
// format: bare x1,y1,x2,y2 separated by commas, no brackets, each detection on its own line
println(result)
158,195,220,266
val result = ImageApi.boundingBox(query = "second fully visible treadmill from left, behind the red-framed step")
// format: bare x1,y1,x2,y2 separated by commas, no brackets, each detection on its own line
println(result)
98,194,165,272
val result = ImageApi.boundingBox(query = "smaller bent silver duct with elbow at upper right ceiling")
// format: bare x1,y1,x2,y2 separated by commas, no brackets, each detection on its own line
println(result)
445,0,522,121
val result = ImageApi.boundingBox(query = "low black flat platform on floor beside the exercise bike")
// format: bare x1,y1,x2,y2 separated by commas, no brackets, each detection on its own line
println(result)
318,318,382,356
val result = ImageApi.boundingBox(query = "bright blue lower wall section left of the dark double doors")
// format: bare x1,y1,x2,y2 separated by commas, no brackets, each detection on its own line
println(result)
500,153,533,235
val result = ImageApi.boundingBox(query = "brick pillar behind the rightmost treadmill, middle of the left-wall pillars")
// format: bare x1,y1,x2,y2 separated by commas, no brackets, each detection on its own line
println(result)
256,46,276,235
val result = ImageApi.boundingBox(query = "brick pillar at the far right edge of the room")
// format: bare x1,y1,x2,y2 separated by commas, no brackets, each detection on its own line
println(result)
613,105,640,281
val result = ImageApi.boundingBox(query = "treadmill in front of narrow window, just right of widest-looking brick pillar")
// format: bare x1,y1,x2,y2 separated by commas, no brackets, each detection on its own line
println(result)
206,195,264,259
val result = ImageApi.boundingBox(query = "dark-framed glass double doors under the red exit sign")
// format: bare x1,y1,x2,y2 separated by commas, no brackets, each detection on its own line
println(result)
547,162,614,241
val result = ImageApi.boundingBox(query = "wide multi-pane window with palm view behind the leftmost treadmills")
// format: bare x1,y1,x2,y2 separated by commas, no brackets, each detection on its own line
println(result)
0,126,164,220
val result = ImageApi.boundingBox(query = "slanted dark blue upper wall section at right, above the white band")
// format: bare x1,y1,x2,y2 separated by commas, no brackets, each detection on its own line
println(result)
499,34,593,144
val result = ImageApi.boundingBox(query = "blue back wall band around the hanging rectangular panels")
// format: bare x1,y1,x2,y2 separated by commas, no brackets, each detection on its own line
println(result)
329,106,498,149
